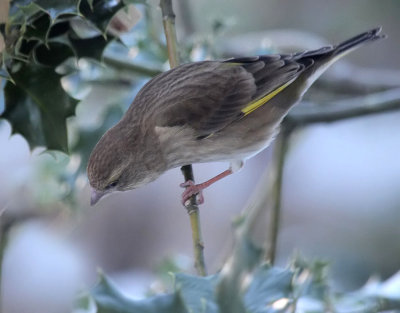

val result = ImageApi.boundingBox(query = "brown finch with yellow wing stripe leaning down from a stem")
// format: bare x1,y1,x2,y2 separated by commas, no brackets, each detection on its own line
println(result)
87,28,385,205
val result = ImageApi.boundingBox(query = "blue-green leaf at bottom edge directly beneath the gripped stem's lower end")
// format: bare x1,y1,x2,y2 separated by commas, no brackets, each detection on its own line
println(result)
175,274,219,313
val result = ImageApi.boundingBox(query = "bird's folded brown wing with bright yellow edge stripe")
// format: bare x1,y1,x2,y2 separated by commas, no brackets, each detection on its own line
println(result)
138,55,306,138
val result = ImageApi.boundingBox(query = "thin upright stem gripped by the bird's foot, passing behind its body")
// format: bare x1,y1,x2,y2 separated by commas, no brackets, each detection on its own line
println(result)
160,0,207,276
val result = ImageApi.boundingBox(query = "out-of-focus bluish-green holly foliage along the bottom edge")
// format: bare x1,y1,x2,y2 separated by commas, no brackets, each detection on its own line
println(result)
74,257,400,313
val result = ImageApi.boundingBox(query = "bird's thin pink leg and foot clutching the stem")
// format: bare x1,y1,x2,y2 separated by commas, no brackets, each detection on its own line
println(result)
180,160,244,205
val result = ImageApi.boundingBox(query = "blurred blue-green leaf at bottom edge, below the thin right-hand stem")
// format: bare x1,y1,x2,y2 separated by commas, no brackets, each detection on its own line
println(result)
244,265,293,313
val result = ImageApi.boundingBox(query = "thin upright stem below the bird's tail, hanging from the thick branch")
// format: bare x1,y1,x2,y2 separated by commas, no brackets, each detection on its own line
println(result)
266,123,293,264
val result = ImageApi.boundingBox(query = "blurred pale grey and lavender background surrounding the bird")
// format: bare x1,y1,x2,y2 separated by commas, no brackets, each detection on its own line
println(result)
0,0,400,312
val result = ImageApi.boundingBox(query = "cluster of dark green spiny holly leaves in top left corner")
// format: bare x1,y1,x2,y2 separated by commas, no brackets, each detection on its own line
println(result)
0,0,136,152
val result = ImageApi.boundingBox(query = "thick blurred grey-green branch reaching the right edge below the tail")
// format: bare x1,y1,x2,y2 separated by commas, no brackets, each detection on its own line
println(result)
285,88,400,127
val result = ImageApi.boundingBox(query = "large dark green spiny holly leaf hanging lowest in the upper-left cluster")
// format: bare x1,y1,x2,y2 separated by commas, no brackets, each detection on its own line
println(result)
0,63,78,153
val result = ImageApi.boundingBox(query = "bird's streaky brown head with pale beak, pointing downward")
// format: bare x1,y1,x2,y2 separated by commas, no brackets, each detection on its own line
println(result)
87,127,163,205
